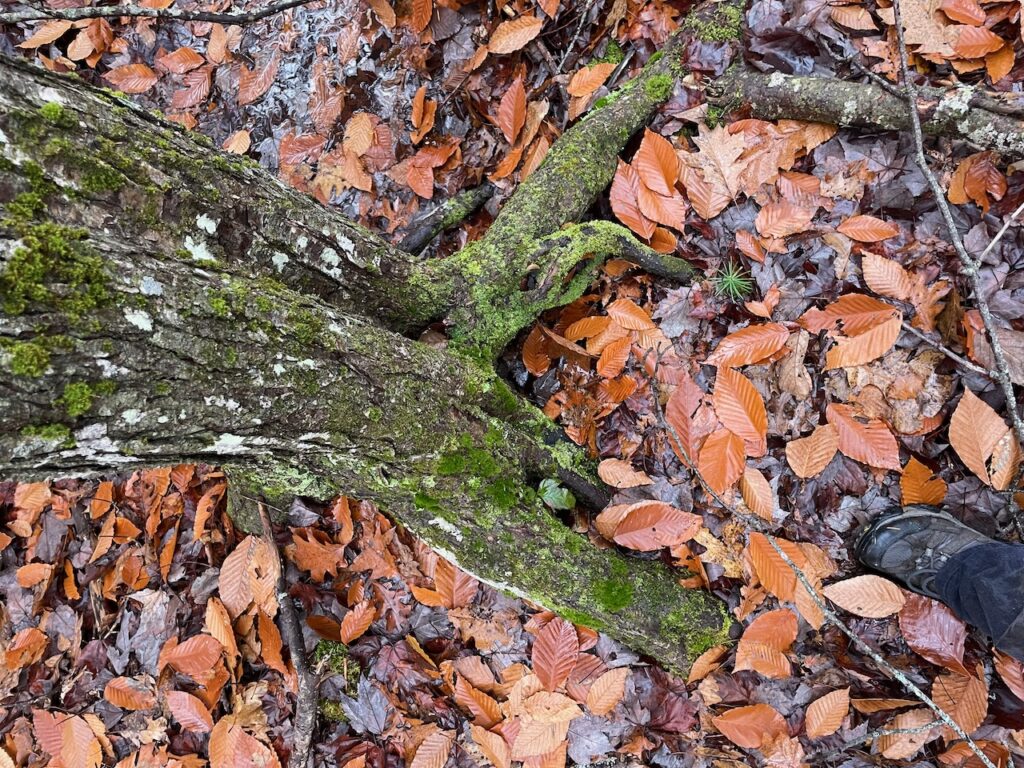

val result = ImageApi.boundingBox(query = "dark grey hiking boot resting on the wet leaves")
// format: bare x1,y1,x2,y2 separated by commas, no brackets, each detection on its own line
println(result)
853,505,992,599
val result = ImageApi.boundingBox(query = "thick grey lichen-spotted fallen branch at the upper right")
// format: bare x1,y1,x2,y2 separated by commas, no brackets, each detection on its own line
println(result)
711,66,1024,160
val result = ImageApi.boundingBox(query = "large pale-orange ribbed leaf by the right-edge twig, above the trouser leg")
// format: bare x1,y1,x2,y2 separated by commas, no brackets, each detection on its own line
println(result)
949,389,1020,490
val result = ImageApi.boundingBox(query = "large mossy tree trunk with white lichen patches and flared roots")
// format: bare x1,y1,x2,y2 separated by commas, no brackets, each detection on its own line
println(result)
0,51,729,670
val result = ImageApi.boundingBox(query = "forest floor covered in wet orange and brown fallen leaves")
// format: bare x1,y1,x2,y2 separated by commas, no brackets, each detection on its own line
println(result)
0,0,1024,768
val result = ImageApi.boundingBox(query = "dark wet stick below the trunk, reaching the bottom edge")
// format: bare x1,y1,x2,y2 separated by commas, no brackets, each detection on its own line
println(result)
257,502,316,768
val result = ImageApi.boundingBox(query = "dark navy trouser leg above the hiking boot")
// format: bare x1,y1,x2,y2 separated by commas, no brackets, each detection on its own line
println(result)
935,542,1024,662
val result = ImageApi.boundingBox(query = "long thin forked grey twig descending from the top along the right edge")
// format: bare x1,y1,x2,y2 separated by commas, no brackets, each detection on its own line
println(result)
893,0,1024,529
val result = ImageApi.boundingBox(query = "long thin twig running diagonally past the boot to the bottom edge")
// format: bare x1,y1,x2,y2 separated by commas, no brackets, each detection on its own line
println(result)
650,368,996,768
